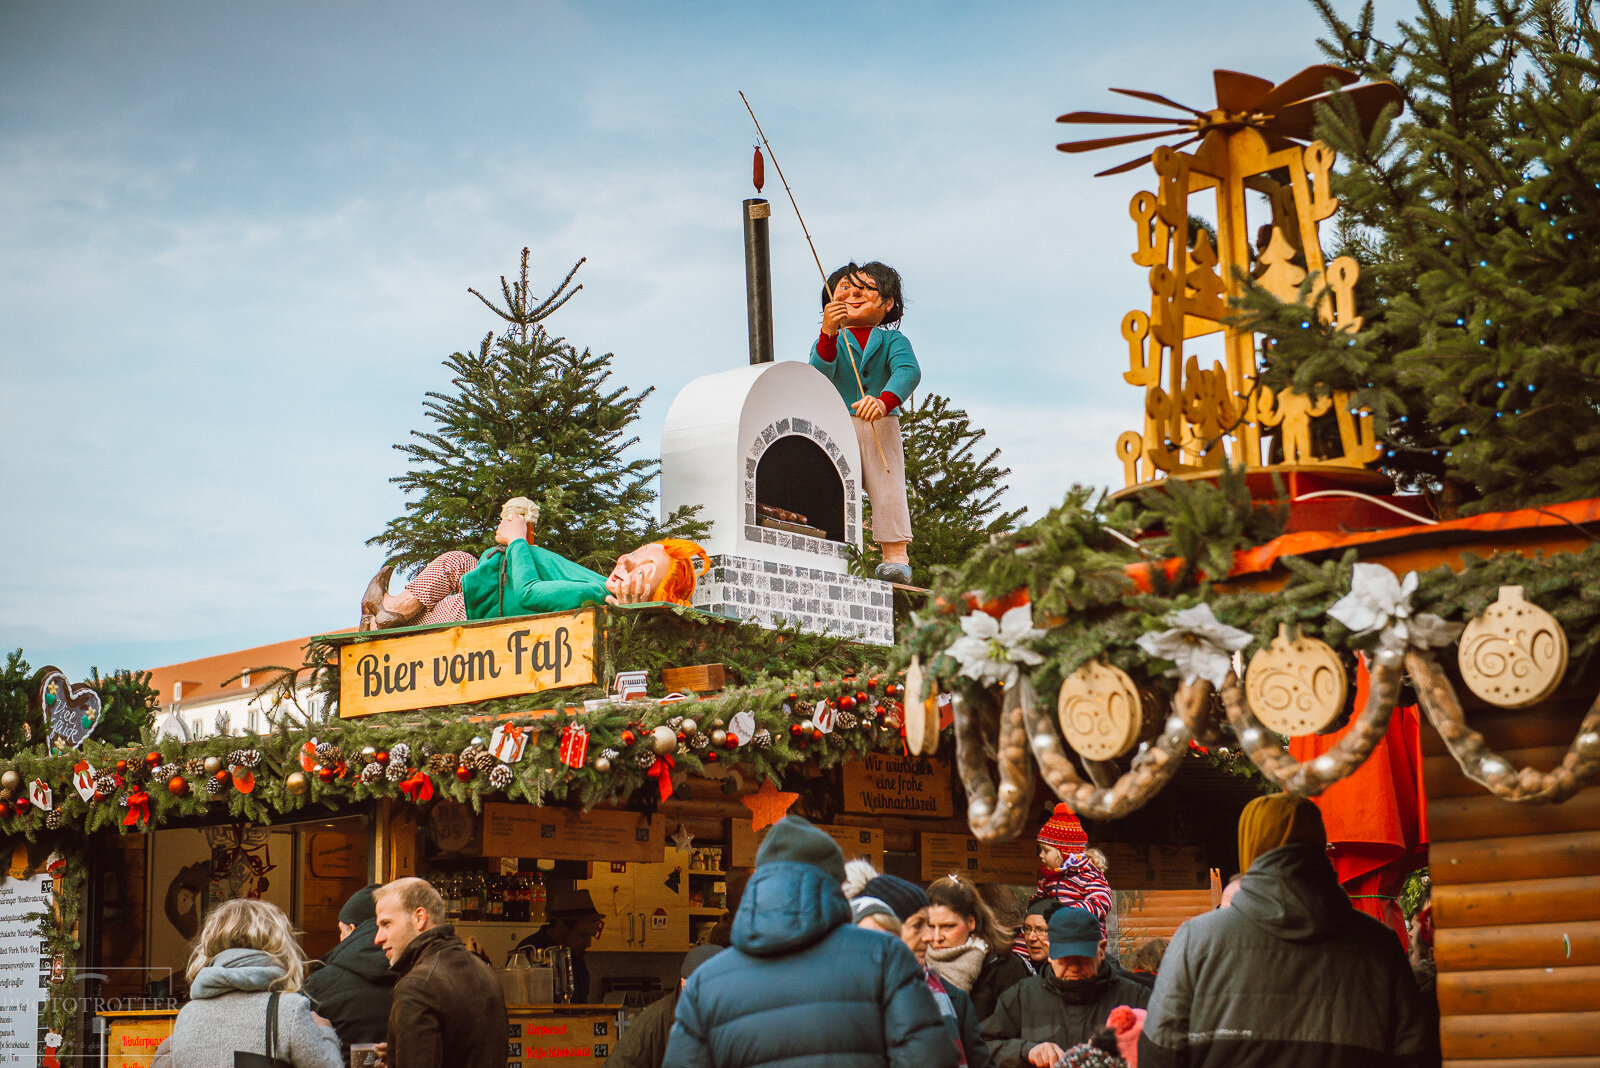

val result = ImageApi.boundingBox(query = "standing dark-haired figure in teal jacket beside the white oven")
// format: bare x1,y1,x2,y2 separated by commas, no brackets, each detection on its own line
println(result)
811,262,922,584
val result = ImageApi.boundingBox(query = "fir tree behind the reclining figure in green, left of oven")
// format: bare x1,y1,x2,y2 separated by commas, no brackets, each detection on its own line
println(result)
368,249,706,572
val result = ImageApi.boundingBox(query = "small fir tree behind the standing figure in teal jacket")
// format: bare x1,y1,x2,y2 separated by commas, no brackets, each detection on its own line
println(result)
861,393,1026,580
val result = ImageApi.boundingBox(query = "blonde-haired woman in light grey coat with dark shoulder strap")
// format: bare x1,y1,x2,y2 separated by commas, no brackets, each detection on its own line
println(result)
152,899,342,1068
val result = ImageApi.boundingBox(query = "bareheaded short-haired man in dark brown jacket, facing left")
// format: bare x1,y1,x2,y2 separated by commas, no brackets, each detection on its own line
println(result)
376,878,507,1068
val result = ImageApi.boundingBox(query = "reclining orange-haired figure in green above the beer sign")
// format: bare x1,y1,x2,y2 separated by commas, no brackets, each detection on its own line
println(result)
362,497,710,630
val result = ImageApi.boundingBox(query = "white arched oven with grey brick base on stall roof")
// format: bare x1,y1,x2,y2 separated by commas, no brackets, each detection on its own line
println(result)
661,361,894,644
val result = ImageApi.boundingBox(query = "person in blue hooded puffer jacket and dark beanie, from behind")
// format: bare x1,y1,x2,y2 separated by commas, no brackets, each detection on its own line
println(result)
666,815,958,1068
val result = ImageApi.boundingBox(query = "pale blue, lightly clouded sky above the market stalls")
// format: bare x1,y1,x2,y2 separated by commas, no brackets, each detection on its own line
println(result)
0,0,1410,678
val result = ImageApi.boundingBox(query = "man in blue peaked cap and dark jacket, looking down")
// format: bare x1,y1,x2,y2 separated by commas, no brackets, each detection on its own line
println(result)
984,905,1150,1068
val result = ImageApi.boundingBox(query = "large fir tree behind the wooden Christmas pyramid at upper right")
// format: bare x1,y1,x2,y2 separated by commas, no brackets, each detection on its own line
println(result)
1246,0,1600,513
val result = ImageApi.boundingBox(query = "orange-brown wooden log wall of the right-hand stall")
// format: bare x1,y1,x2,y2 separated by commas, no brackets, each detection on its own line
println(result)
1422,684,1600,1068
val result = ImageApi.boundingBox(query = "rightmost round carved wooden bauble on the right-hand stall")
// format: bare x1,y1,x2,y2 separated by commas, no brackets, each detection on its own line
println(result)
1458,585,1566,708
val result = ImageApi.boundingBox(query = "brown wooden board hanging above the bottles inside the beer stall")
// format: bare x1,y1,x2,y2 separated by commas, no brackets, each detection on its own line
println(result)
483,801,667,863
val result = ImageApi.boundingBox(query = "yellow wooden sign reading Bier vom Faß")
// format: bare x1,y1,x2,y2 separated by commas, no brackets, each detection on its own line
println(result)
339,608,595,719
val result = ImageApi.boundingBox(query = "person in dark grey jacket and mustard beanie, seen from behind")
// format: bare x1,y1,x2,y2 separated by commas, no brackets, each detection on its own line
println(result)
1139,793,1438,1068
